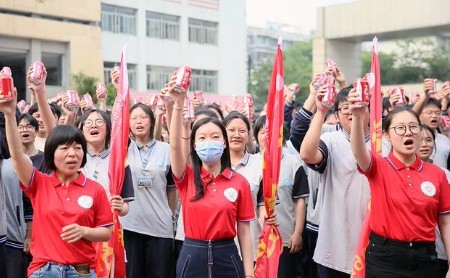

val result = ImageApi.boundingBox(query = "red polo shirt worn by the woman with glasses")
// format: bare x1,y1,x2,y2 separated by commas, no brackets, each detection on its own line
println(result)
358,152,450,242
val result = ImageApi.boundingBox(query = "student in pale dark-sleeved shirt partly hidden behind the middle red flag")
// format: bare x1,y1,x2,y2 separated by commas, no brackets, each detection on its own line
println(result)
253,116,309,278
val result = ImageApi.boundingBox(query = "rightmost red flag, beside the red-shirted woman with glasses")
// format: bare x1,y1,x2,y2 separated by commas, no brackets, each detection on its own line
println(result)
351,37,382,278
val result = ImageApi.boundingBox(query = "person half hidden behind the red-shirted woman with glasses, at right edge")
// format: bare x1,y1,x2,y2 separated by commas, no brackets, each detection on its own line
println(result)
417,125,450,278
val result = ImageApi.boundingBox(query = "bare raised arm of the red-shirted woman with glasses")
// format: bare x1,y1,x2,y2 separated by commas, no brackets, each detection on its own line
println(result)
348,89,371,172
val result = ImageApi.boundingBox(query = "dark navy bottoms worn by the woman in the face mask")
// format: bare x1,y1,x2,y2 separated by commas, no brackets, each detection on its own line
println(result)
177,238,244,278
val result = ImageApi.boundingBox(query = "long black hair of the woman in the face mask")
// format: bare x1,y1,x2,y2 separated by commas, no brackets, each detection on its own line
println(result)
190,117,231,202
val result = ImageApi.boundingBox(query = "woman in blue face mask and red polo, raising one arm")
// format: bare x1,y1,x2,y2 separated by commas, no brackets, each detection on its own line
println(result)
169,84,255,278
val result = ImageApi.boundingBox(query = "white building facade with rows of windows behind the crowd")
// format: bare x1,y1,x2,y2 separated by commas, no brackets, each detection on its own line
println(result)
101,0,247,95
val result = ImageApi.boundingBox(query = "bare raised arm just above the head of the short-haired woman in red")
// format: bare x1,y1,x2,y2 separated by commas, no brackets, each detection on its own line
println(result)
27,67,56,134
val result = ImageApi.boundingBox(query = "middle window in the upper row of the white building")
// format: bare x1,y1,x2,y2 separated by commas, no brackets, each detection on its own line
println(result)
146,12,180,41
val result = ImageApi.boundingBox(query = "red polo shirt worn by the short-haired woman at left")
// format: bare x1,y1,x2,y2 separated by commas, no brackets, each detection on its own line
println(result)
21,168,113,276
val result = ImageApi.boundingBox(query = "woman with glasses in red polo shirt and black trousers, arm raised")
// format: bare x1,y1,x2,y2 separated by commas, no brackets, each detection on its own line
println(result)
349,86,450,278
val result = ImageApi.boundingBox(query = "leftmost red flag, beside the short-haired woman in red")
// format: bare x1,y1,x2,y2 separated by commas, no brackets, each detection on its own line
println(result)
96,46,130,278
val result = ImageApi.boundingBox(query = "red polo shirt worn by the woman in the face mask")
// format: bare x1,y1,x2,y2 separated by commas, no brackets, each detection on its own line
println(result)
174,165,255,240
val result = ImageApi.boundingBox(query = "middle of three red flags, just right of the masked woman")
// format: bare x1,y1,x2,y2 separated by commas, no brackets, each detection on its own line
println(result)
255,38,284,278
